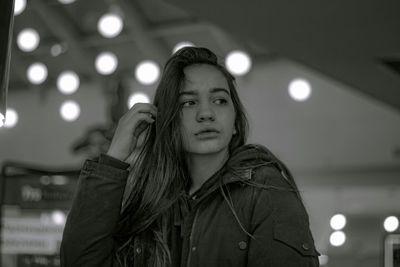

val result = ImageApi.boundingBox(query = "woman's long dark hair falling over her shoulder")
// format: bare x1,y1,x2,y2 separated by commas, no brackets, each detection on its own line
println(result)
116,47,248,267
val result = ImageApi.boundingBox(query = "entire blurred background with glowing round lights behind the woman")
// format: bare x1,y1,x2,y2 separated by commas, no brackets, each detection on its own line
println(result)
0,0,400,267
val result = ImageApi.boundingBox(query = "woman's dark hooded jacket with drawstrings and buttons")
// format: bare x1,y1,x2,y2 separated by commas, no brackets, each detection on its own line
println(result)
61,145,319,267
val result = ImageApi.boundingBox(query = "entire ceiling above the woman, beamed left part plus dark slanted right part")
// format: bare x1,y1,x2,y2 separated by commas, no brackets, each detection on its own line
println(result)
10,0,400,110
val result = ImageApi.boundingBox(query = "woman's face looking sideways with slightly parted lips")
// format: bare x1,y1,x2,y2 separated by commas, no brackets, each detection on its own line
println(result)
179,64,236,155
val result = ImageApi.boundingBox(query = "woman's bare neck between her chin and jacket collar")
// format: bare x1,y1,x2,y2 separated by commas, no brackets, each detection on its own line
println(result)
188,151,229,195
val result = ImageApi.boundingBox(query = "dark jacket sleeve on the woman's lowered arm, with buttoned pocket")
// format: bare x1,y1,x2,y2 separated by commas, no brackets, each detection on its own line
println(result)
247,167,319,267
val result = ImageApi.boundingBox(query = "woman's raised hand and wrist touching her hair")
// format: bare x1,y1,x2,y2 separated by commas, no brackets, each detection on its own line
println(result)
107,103,157,163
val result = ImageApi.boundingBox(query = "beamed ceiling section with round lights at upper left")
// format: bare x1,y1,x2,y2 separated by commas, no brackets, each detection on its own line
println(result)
10,0,272,90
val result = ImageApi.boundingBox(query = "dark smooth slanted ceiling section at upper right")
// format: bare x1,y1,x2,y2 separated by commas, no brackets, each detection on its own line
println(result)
168,0,400,110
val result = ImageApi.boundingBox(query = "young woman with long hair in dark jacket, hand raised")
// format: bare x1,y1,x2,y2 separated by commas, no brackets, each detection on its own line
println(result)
61,47,319,267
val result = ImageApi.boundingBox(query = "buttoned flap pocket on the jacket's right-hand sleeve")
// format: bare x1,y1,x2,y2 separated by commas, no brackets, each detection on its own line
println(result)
273,221,320,257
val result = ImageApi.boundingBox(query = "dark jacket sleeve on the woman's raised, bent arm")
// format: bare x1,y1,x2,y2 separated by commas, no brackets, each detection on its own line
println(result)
60,155,129,267
